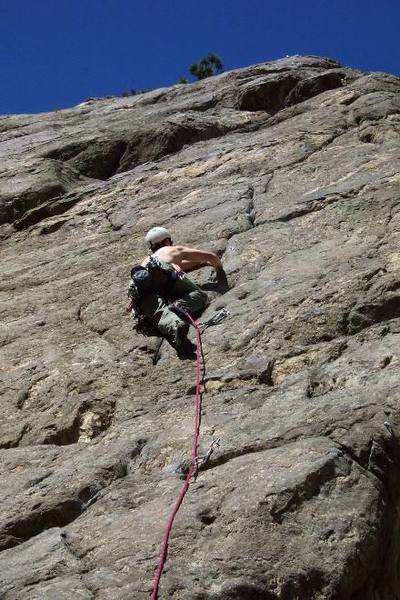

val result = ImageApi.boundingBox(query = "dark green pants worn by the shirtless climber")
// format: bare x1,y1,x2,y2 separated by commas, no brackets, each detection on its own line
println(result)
140,275,208,338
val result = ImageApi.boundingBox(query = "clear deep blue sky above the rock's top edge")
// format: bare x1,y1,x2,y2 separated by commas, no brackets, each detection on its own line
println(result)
0,0,400,114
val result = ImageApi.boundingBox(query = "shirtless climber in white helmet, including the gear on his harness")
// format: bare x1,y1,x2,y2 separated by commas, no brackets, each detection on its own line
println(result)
128,227,229,358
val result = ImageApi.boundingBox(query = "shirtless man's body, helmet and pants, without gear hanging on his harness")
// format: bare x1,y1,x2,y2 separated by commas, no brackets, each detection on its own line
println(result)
132,227,229,357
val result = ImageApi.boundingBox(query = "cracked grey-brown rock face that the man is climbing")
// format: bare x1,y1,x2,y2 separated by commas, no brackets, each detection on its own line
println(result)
0,57,400,600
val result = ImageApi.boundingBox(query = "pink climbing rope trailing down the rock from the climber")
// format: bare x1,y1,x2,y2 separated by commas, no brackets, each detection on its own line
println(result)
150,313,202,600
